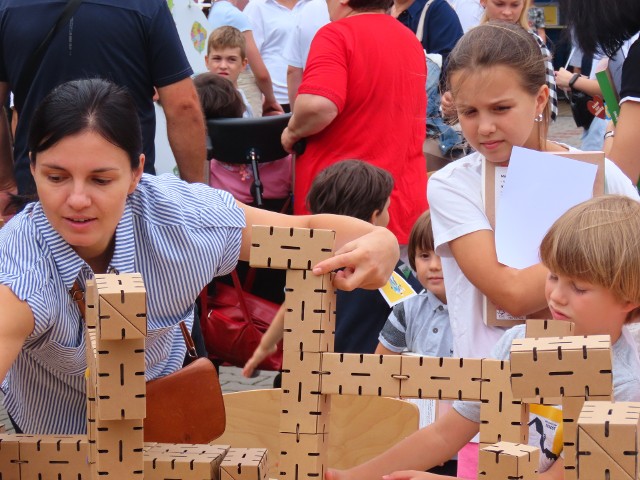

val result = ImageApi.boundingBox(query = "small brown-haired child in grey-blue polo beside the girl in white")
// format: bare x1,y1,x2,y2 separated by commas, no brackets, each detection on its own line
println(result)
375,210,453,357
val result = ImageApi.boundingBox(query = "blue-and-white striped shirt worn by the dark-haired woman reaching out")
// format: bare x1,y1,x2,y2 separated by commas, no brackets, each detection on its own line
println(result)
0,174,245,434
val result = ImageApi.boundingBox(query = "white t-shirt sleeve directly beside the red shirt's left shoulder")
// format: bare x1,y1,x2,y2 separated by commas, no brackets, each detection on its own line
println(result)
283,0,330,68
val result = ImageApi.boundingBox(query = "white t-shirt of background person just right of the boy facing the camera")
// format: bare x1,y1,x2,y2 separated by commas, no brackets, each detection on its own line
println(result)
244,0,309,104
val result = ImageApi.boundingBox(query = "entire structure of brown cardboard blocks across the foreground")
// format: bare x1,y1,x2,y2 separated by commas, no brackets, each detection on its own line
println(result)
0,227,640,480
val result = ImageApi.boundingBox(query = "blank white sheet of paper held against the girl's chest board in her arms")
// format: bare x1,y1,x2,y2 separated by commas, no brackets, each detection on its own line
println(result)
495,147,598,268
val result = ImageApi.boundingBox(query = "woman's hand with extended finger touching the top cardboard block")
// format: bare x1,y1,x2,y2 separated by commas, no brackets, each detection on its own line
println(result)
313,227,400,291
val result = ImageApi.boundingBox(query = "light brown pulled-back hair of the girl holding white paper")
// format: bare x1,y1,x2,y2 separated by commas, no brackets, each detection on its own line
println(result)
447,20,551,148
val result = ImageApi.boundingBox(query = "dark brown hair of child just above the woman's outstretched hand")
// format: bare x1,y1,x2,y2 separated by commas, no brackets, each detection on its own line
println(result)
307,160,393,222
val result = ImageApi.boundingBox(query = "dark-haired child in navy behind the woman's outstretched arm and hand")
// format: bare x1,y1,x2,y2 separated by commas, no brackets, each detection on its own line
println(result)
242,160,420,377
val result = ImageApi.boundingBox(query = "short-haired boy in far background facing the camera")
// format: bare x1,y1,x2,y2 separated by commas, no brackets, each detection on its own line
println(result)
204,27,253,118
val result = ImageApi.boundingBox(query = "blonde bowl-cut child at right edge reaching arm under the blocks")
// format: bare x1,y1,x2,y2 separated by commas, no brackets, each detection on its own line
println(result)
325,195,640,480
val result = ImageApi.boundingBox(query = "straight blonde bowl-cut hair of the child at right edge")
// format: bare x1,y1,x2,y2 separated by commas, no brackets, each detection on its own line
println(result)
540,195,640,320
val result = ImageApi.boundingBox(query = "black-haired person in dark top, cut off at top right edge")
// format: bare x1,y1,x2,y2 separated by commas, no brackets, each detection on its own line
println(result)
560,0,640,183
